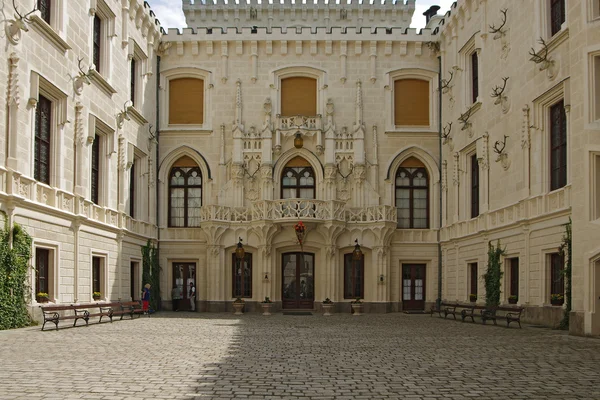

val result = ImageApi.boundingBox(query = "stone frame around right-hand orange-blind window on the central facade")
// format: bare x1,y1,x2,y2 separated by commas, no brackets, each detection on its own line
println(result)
385,67,439,135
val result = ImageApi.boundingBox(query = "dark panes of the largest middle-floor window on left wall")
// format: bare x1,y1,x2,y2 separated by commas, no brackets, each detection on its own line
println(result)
33,95,52,185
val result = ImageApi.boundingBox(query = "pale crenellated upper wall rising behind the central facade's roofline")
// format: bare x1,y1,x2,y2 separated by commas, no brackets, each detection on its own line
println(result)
183,0,415,28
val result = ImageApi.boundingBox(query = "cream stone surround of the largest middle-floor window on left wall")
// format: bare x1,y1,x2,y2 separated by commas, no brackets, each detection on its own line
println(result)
29,71,69,188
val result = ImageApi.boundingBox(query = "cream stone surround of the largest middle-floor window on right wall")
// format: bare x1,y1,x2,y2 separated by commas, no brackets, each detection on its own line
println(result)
532,78,573,193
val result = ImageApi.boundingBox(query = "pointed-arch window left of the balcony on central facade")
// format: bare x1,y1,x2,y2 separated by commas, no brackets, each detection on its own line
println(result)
169,156,202,227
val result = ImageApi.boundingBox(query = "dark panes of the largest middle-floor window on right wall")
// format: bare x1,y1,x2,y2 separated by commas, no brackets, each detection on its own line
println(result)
550,100,567,190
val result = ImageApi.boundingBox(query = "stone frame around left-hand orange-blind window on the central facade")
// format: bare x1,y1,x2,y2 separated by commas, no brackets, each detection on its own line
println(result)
160,66,214,135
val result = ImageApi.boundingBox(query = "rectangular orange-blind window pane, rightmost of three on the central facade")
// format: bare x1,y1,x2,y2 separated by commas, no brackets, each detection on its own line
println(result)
394,79,429,126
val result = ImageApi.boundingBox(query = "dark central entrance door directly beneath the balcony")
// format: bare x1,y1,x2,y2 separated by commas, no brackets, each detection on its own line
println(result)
281,253,315,310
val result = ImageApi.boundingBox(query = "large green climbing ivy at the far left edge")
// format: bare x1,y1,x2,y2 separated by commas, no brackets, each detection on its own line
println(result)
0,224,31,330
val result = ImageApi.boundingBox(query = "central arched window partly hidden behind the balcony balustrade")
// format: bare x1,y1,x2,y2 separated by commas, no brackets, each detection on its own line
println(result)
281,157,315,199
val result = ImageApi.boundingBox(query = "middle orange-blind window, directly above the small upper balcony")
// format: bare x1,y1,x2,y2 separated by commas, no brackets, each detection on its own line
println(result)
281,77,317,117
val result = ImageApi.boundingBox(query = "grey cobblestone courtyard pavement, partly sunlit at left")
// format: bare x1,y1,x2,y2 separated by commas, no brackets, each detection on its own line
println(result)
0,313,600,400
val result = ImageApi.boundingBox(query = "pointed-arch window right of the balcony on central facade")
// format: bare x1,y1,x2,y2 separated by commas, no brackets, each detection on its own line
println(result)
396,157,429,229
